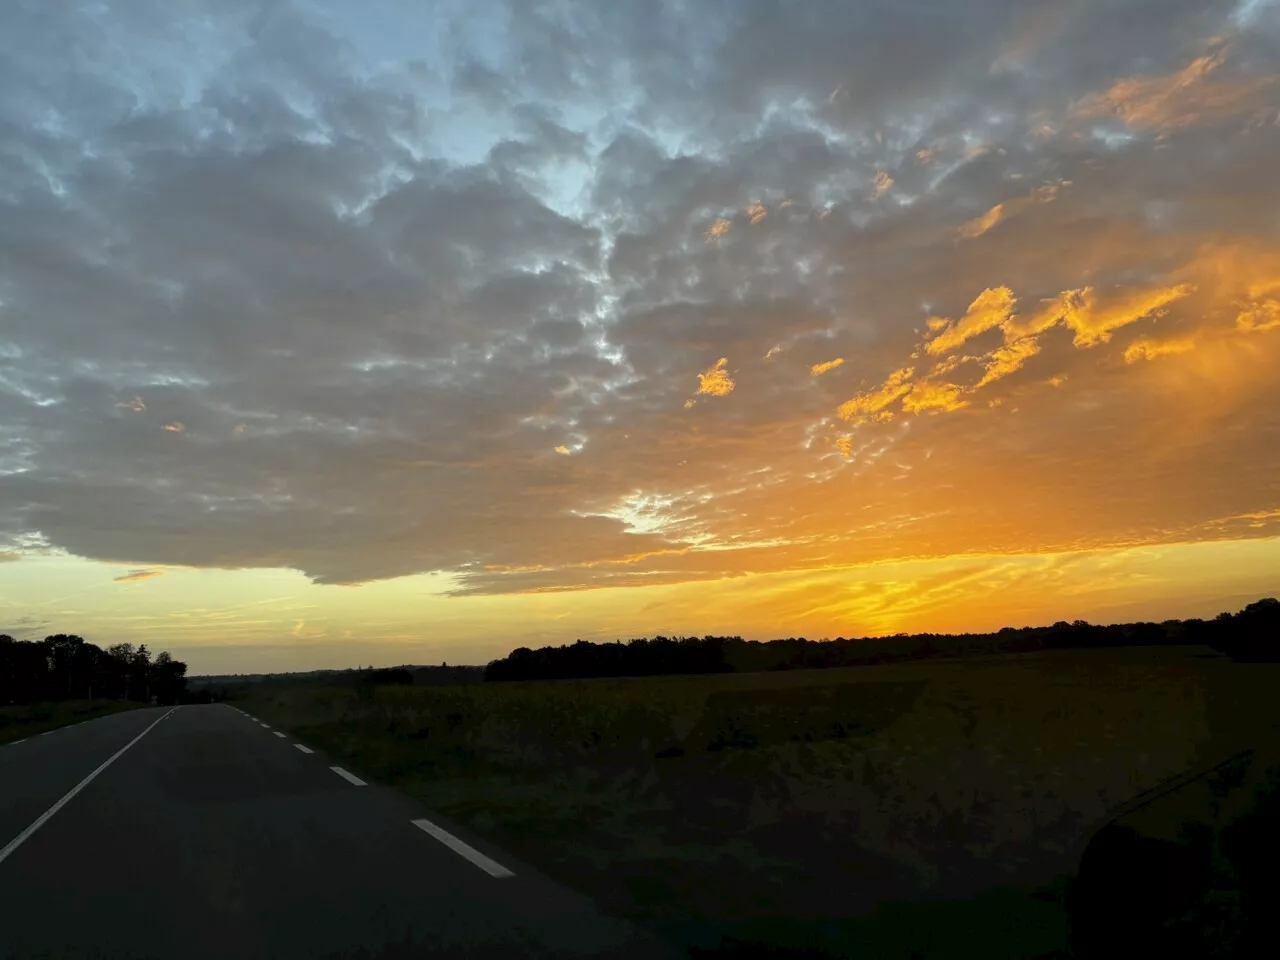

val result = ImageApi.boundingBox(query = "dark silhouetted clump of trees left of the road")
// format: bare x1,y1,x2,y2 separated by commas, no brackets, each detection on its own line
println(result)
0,634,187,705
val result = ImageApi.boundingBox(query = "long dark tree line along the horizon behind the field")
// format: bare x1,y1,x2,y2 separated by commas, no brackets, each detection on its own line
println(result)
484,598,1280,681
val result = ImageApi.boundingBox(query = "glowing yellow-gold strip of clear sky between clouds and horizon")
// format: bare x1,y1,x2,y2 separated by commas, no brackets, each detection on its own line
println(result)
0,542,1280,675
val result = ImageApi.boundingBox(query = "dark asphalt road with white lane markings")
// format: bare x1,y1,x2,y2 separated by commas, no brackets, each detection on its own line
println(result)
0,704,678,960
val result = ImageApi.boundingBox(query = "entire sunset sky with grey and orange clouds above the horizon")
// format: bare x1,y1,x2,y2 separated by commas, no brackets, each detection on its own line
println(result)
0,0,1280,673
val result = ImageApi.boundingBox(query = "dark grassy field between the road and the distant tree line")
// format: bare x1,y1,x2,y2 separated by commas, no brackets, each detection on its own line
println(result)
238,648,1280,957
